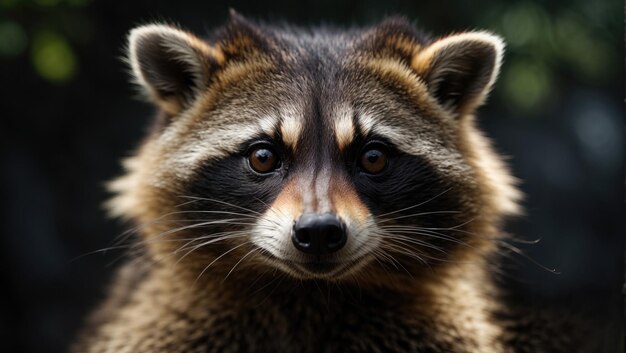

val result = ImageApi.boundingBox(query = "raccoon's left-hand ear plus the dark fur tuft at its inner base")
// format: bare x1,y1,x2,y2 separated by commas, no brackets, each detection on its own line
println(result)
128,11,275,115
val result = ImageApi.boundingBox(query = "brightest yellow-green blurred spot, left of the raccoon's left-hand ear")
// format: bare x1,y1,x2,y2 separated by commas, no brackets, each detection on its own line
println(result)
32,31,77,82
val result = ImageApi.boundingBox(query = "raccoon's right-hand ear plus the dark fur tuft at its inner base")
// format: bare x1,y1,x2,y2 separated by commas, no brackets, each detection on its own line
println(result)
357,17,504,116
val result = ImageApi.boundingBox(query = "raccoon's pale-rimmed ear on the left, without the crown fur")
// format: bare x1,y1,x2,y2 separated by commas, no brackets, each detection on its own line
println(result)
128,24,224,114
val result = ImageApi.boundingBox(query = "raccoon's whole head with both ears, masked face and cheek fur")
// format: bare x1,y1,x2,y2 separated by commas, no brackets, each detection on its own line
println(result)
110,15,518,284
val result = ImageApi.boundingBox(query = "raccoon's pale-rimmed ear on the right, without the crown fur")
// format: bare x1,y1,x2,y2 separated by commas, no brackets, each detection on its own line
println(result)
411,32,504,116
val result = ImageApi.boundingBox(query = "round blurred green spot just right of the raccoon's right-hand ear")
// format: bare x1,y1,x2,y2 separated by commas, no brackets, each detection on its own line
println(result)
504,60,553,110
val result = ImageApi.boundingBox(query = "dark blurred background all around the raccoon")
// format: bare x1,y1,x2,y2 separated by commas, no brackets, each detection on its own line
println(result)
0,0,625,352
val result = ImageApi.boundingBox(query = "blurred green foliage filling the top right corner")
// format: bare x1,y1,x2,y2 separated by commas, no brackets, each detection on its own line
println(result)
484,1,621,111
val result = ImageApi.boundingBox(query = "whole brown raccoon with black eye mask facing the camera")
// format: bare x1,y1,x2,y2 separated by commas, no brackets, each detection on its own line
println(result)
74,13,588,353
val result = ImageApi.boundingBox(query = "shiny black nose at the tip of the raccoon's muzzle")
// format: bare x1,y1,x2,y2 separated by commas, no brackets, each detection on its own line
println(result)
291,213,347,255
